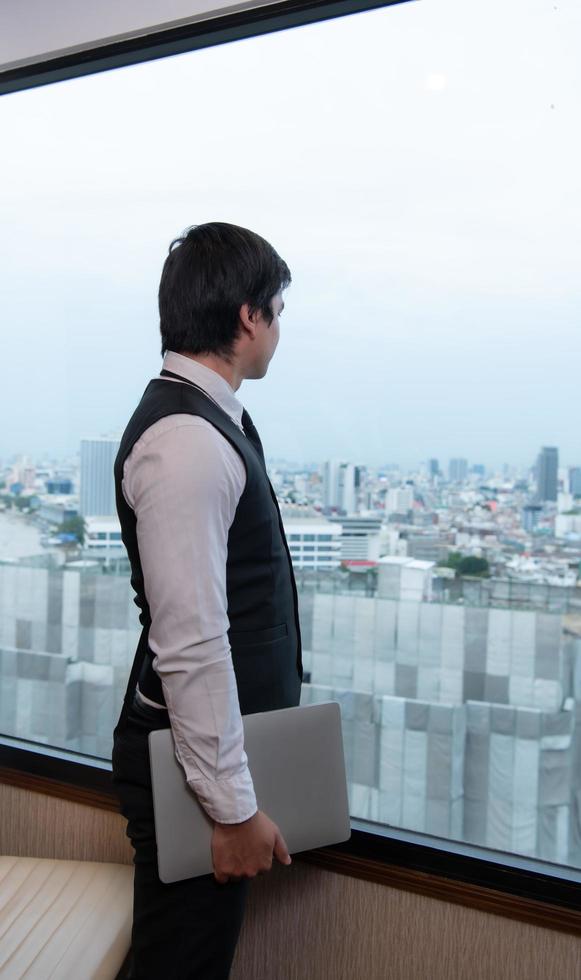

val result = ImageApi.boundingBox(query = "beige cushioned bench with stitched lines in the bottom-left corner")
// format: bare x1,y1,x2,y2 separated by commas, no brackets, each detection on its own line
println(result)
0,857,133,980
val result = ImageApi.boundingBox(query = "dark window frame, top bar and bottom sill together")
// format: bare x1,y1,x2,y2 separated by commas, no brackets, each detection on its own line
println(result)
0,0,581,935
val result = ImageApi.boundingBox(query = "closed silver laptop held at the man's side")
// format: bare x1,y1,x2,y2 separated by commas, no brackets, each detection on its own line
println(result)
149,701,351,884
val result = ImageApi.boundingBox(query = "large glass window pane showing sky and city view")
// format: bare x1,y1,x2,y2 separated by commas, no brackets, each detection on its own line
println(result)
0,0,581,867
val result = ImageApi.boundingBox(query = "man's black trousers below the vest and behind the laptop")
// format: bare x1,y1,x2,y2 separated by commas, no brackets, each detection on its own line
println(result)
113,704,250,980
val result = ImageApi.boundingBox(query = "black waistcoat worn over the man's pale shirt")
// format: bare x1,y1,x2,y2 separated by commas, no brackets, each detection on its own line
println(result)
114,379,303,714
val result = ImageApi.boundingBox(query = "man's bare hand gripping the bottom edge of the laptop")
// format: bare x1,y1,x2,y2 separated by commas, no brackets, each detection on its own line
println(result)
212,810,291,884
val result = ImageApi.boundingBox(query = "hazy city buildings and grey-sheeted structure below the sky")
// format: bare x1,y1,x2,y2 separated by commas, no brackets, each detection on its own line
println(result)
0,436,581,867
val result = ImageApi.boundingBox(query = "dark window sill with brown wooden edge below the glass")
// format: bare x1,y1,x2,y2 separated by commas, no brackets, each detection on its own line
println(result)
0,737,581,935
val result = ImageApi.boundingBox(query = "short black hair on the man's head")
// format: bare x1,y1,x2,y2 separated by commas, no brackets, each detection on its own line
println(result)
159,221,291,359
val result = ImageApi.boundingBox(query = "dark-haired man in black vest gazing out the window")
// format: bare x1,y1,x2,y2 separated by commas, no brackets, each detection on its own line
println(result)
113,222,302,980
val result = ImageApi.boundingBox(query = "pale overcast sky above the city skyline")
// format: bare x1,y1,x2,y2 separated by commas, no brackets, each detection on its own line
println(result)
0,0,581,466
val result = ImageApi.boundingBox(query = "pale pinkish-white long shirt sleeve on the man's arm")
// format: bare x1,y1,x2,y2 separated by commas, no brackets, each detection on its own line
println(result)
123,415,257,823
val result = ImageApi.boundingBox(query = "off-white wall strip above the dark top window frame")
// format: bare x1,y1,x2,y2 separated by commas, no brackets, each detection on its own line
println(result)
0,0,275,71
